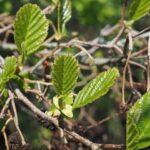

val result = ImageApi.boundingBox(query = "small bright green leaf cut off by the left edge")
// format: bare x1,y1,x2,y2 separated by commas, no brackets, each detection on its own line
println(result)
0,56,17,91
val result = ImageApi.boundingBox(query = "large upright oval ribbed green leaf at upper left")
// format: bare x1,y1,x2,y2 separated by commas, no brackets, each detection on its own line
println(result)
14,3,49,57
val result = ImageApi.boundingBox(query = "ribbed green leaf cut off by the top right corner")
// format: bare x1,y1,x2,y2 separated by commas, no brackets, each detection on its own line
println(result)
129,0,150,21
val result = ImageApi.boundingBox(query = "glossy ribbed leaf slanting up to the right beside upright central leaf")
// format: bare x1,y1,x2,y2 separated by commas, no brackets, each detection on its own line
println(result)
73,68,119,108
